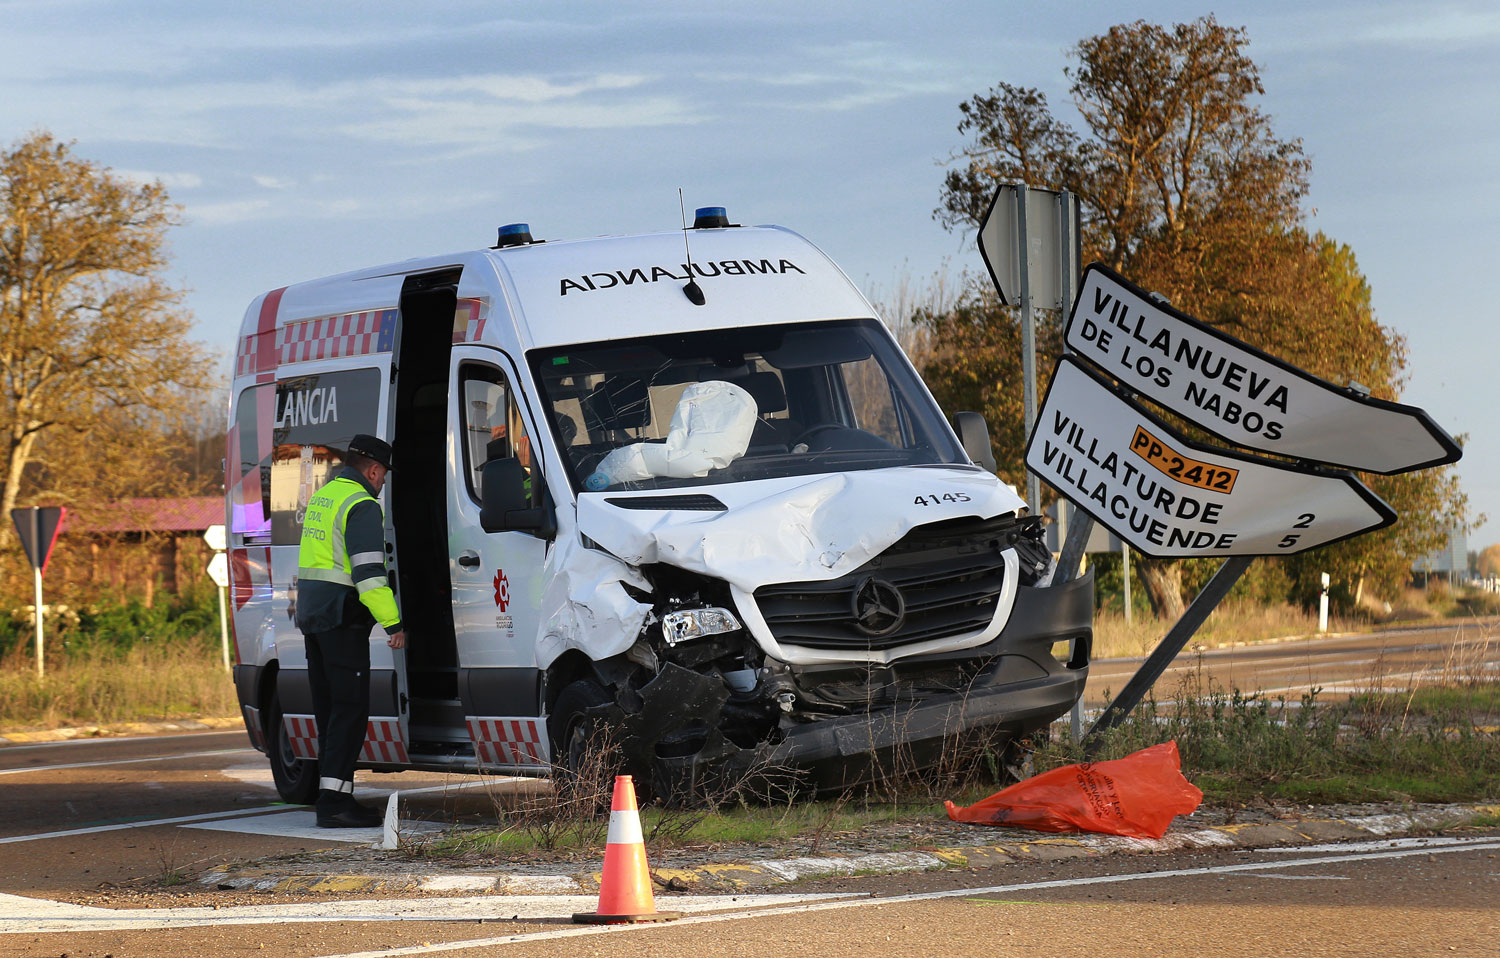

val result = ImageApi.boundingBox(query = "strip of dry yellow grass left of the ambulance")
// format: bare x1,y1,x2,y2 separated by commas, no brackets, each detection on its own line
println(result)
0,643,239,729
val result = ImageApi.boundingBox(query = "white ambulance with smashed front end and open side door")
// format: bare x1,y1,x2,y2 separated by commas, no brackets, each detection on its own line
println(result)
225,207,1094,802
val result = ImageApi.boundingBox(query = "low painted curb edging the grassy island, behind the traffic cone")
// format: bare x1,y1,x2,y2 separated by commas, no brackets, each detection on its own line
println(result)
198,805,1500,895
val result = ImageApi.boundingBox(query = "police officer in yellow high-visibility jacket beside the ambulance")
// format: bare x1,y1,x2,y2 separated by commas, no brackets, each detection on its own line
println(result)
297,435,407,828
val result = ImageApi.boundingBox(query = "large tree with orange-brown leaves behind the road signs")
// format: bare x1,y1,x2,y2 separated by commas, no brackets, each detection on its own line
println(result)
921,16,1464,618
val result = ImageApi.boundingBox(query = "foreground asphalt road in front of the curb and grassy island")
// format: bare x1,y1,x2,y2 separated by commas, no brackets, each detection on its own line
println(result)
0,835,1500,958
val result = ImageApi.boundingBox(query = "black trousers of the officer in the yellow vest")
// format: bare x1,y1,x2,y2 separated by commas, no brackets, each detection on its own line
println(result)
306,627,371,795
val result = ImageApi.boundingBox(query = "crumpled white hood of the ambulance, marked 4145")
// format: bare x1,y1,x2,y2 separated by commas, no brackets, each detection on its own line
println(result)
578,466,1025,592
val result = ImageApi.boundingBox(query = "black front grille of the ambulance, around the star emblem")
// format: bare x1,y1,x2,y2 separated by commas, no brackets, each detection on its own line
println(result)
755,516,1017,649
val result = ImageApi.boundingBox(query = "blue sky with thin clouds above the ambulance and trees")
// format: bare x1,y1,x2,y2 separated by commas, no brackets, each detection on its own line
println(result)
0,0,1500,549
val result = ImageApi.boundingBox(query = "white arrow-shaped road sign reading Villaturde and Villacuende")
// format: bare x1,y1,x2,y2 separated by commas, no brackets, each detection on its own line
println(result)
1026,357,1397,558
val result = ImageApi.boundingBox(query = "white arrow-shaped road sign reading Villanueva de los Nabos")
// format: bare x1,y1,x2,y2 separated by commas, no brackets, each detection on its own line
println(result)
1065,264,1463,475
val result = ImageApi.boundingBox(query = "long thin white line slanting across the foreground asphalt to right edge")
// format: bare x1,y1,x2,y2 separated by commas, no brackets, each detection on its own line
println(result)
307,838,1500,958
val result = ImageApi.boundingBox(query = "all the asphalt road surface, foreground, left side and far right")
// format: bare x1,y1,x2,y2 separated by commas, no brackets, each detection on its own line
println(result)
0,617,1500,957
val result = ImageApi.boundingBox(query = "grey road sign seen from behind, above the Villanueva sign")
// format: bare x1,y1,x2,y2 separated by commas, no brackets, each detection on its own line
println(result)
980,184,1079,309
